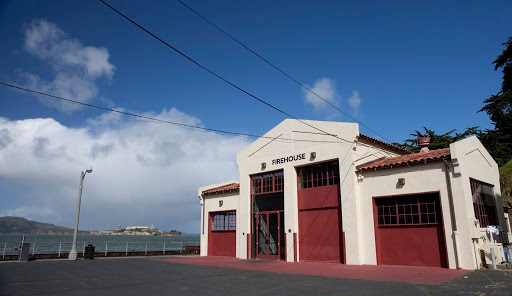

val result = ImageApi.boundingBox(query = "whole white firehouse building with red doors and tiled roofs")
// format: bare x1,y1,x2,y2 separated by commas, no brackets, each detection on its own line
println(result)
198,119,512,269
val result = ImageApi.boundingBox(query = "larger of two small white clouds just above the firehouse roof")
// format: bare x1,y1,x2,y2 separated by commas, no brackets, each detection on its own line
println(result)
302,77,341,111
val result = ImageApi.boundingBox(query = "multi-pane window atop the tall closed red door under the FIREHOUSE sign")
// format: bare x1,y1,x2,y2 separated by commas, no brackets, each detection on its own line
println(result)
298,161,340,189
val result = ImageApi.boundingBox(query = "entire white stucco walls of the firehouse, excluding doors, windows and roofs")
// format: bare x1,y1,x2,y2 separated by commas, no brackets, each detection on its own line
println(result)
199,120,506,269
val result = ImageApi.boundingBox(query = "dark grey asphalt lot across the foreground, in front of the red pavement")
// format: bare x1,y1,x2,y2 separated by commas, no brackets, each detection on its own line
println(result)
0,258,512,296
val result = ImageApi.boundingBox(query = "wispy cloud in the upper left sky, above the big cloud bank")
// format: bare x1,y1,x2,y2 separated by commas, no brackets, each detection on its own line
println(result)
20,19,115,112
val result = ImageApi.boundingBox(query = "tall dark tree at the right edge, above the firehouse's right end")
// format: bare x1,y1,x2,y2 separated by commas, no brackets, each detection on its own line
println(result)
479,37,512,166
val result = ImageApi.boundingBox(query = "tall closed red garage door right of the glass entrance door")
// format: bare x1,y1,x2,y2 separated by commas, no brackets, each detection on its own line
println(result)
298,161,343,262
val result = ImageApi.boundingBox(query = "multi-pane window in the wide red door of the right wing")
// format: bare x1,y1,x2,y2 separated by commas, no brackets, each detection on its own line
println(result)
375,194,441,225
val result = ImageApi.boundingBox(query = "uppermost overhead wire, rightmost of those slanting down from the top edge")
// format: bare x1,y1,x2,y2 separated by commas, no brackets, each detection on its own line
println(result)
175,0,392,143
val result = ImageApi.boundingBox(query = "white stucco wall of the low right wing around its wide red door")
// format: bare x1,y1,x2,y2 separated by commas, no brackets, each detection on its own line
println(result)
358,137,508,269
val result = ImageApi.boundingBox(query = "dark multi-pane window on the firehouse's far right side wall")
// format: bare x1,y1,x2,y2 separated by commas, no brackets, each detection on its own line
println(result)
469,179,498,227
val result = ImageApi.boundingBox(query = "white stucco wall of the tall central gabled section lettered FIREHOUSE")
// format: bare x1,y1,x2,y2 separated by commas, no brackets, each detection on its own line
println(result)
237,119,404,264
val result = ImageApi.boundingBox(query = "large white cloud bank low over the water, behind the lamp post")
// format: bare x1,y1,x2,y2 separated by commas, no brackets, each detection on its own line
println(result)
0,109,249,233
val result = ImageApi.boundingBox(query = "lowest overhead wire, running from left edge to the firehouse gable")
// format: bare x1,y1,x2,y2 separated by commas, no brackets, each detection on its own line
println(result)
0,81,342,144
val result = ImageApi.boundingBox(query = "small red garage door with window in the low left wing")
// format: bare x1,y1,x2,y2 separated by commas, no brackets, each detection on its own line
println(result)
208,211,236,257
